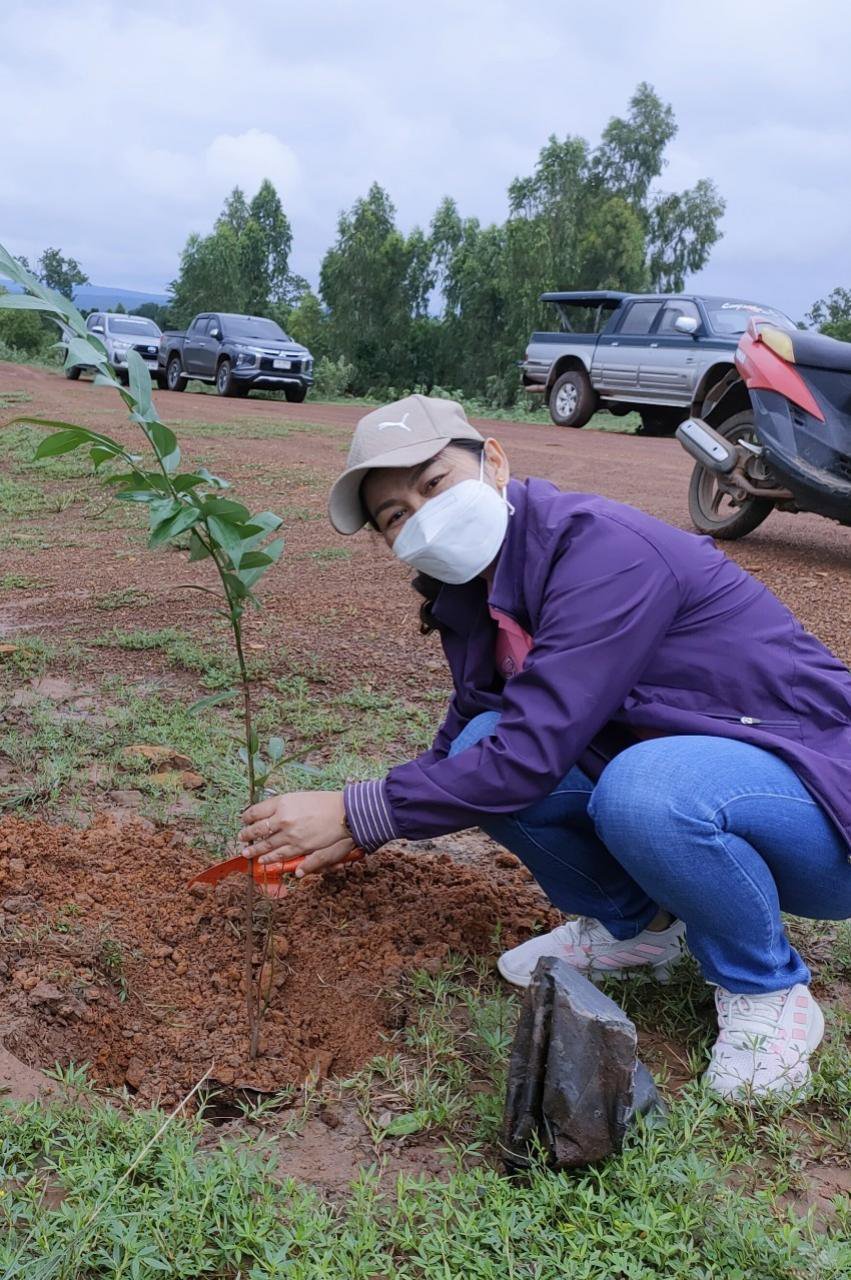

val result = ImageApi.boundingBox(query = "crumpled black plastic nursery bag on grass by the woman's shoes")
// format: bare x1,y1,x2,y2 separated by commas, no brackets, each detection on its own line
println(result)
503,957,662,1170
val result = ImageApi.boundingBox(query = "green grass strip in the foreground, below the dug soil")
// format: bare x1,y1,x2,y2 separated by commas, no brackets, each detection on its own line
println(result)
0,963,851,1280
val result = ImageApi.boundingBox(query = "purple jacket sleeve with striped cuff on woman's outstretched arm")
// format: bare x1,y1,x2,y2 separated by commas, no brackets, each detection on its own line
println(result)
346,517,681,849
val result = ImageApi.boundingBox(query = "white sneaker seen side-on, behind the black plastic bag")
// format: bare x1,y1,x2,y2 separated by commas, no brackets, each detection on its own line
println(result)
497,915,686,987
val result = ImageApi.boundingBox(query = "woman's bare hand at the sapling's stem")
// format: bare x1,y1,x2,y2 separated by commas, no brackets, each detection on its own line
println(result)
239,791,354,877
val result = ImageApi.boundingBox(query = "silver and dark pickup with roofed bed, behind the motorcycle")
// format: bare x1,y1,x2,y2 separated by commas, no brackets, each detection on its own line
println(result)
521,289,795,435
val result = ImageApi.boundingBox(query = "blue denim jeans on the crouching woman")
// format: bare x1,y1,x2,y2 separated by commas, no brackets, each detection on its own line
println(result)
449,712,851,993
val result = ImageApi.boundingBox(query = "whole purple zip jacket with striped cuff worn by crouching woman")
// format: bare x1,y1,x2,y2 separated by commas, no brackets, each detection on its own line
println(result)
346,480,851,850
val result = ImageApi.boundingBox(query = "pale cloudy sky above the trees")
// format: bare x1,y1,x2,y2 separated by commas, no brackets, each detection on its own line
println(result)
0,0,851,317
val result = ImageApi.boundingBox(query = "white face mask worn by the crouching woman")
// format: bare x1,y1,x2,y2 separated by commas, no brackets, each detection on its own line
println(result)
393,453,513,585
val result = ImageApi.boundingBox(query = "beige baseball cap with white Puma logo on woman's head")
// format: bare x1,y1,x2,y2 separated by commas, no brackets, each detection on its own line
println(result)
328,396,485,534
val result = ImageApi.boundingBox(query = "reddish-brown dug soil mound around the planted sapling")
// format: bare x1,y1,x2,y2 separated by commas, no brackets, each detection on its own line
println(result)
0,818,550,1103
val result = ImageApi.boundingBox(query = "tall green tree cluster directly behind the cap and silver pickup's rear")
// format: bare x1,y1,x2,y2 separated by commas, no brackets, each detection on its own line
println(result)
314,83,724,403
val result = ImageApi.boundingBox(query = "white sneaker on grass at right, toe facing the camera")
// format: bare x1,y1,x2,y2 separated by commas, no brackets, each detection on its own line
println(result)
704,983,824,1098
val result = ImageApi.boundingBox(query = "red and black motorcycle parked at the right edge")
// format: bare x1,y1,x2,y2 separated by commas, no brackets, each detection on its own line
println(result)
677,325,851,539
